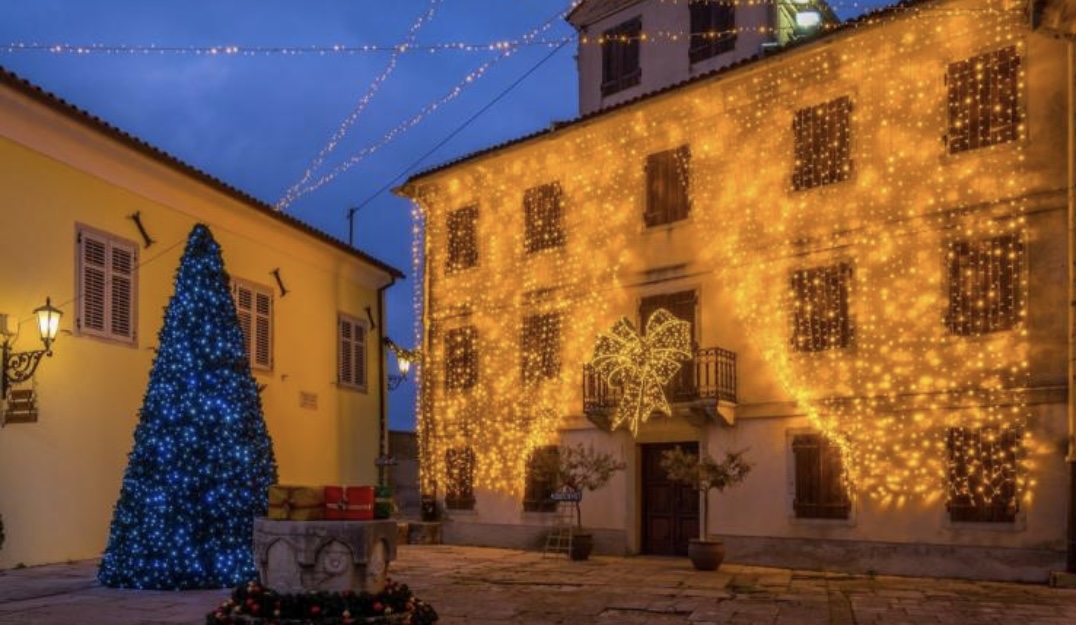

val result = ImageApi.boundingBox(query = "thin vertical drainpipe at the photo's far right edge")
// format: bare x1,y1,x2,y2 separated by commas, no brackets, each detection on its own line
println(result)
1065,32,1076,573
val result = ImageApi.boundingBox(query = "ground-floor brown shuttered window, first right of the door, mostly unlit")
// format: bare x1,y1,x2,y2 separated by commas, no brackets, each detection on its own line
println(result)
792,434,851,519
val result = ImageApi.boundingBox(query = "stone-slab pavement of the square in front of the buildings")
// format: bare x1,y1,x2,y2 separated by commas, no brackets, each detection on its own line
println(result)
0,545,1076,625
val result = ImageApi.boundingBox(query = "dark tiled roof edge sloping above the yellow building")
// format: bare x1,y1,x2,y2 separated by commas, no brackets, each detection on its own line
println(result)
0,67,405,279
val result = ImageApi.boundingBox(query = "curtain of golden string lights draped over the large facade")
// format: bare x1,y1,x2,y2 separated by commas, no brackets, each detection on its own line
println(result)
407,1,1043,509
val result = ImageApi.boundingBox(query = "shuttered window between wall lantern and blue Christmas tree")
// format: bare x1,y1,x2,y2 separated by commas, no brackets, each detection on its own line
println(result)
76,226,138,344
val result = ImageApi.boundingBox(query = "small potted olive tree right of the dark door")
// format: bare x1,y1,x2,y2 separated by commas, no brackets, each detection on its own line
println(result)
661,446,751,571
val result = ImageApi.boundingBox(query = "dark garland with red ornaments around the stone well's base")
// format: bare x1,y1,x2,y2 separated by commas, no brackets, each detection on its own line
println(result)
206,580,437,625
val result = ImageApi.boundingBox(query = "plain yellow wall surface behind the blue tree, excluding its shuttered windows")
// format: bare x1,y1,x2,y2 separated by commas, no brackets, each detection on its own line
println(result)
0,81,391,568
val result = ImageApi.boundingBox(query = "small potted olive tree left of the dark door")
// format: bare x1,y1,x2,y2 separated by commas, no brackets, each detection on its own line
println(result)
532,443,626,559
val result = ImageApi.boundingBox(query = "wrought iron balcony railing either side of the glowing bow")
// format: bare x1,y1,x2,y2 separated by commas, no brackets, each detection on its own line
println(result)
583,347,736,416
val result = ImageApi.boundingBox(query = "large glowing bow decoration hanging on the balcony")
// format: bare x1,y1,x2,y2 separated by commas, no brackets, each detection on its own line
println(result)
591,309,691,437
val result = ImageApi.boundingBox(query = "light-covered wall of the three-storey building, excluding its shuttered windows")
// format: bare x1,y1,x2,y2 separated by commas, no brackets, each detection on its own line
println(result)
407,2,1067,548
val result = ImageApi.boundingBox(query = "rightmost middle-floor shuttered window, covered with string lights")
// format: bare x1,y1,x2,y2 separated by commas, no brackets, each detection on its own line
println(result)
946,235,1023,337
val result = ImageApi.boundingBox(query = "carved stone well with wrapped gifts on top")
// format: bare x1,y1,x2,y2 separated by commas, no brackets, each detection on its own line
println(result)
254,519,397,593
